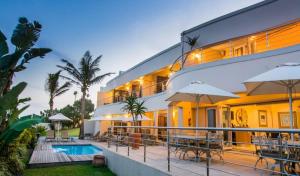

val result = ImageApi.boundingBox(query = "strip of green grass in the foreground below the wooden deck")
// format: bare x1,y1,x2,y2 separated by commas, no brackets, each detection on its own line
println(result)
24,164,115,176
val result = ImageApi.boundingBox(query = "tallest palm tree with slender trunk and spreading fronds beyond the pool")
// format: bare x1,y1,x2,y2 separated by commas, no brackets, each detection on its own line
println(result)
58,51,113,139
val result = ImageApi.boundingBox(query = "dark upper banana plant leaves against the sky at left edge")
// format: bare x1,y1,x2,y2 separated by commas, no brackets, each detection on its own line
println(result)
0,17,51,96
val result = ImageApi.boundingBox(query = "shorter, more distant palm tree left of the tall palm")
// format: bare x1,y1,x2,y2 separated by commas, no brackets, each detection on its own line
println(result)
45,71,71,116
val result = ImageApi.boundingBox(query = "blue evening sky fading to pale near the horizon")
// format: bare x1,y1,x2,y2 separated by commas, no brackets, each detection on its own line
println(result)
0,0,260,114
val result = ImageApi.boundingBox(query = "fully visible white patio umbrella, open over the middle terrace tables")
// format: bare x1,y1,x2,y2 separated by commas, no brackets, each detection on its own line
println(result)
166,81,239,127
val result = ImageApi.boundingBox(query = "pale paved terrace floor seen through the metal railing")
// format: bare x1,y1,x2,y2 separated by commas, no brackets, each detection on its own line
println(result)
94,143,276,176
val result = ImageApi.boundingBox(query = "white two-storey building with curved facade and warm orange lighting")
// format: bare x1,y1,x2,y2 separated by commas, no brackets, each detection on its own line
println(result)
95,0,300,142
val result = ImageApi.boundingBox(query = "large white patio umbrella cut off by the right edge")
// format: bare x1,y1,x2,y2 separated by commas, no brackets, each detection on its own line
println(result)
244,63,300,133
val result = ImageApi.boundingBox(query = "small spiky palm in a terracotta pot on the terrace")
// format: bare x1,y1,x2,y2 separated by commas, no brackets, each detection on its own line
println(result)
123,94,147,149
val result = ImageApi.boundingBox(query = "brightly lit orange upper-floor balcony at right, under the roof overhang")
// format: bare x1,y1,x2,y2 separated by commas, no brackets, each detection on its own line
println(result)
183,21,300,67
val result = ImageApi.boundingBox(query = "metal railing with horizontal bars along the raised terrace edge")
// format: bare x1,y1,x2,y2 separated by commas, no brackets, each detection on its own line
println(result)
105,126,300,175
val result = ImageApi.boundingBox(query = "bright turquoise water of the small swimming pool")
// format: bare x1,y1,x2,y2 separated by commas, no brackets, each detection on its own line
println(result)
52,145,102,155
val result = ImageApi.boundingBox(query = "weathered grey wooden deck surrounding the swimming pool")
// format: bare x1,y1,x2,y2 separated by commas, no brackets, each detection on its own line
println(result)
29,139,102,167
